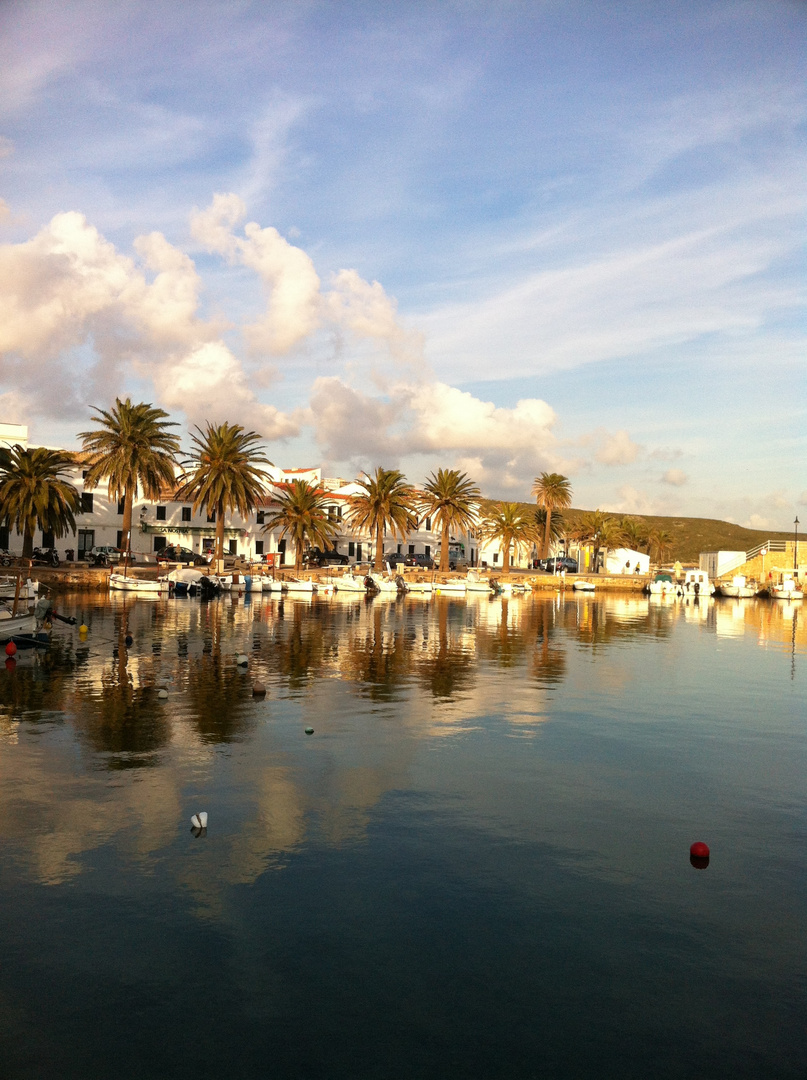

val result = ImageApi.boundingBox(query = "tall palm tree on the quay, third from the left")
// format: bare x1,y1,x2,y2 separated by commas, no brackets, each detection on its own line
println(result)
176,422,271,559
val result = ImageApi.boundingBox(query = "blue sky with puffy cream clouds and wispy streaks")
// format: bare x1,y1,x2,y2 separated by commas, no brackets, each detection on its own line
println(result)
0,0,807,529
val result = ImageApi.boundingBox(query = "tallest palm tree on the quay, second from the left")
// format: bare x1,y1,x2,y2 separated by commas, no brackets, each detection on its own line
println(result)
79,397,179,552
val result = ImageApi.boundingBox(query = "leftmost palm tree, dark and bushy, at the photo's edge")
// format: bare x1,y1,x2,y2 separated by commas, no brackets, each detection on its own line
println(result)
0,443,81,558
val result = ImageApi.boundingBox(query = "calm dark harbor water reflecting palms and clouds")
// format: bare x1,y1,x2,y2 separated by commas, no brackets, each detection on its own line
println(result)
0,594,807,1080
